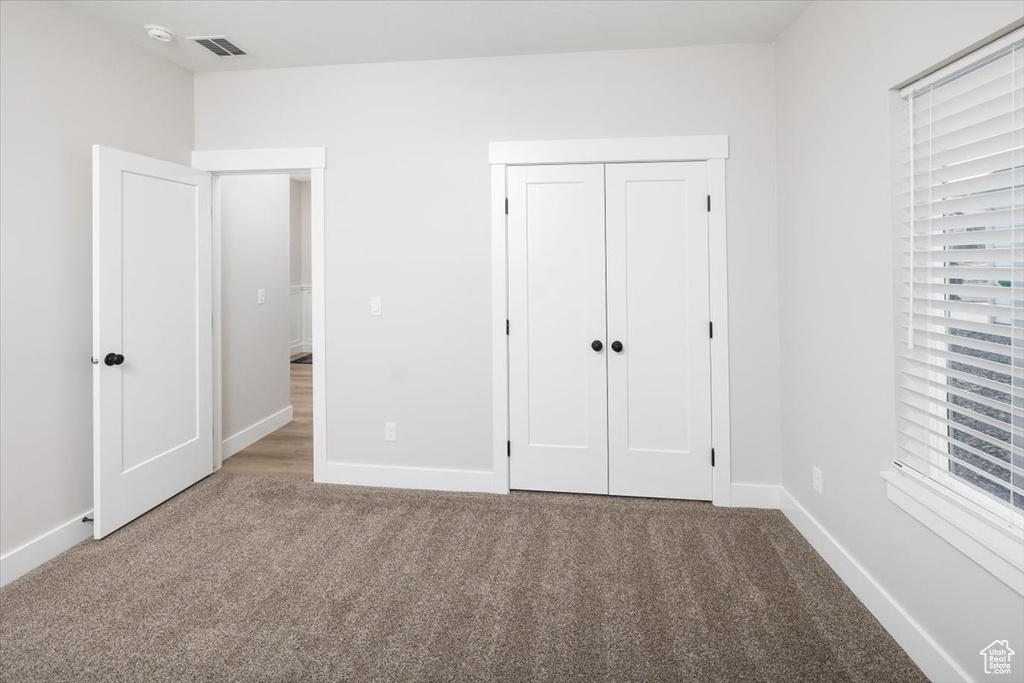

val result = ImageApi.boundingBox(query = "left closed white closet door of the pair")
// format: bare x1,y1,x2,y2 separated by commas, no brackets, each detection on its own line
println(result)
507,165,608,494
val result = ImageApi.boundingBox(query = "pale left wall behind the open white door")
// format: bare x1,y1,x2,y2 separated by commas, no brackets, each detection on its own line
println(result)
0,0,193,554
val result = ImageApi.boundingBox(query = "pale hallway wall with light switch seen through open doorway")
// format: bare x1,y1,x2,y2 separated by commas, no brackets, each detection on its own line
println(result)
220,175,292,446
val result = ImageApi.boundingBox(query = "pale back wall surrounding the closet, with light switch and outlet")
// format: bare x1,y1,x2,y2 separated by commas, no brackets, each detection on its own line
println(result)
196,45,779,483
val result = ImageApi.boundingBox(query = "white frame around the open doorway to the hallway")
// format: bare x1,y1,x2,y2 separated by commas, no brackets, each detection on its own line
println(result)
191,147,327,480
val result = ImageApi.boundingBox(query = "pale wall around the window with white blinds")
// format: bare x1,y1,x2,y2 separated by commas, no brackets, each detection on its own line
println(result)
776,2,1024,680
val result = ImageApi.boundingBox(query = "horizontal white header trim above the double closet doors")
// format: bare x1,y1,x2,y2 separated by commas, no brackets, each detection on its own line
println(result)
489,135,729,166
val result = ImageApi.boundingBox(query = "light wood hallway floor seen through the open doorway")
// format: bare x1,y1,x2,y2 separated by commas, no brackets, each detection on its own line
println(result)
222,362,313,480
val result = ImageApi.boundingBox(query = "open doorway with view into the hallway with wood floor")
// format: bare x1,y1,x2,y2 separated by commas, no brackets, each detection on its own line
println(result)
217,173,313,479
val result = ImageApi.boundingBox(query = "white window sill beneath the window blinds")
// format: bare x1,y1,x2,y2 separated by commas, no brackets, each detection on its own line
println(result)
882,467,1024,595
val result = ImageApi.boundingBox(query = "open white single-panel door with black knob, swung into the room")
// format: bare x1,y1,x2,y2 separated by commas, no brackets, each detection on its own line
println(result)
92,145,213,539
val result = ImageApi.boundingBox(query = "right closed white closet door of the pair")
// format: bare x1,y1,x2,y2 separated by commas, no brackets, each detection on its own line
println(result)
605,163,712,501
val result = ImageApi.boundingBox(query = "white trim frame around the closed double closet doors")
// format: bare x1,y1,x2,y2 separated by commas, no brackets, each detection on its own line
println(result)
489,135,732,506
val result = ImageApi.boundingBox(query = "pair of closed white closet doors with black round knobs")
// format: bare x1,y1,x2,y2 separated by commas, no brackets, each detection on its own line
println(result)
506,163,712,500
